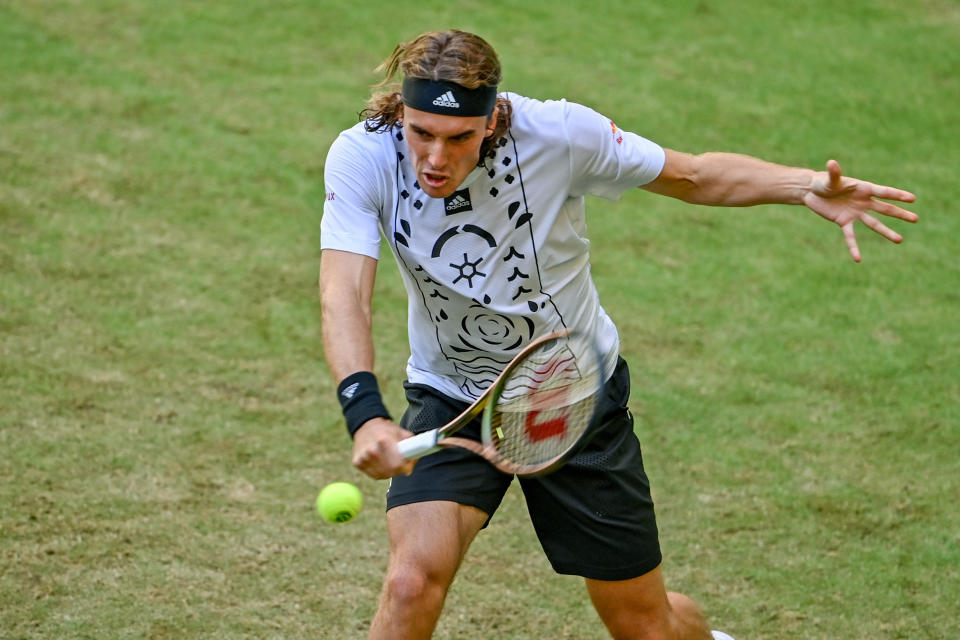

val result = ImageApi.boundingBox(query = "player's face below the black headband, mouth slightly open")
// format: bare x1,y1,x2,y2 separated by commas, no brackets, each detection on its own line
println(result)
403,106,497,198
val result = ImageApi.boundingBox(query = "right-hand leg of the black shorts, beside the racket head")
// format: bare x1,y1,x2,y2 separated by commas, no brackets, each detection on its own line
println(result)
521,360,662,580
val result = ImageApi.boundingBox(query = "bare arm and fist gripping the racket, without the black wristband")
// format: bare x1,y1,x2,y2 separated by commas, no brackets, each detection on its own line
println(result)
320,249,413,479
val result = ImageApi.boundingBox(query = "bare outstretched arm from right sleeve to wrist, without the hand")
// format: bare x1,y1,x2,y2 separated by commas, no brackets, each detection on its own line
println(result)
642,149,816,207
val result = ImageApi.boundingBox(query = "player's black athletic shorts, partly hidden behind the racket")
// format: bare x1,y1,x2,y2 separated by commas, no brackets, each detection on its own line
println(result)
387,358,662,580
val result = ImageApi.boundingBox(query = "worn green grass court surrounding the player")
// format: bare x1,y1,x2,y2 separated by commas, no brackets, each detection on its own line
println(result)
0,0,960,640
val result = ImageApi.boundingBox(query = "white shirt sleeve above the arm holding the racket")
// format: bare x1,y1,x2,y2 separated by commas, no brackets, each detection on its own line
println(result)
320,130,383,259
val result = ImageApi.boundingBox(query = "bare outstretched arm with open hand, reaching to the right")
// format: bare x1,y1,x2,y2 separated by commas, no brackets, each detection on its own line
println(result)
643,149,917,262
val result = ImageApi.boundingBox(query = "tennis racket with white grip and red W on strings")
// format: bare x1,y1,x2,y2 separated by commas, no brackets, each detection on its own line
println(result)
398,329,605,476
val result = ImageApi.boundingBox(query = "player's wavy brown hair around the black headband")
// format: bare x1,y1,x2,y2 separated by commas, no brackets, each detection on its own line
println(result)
360,29,513,164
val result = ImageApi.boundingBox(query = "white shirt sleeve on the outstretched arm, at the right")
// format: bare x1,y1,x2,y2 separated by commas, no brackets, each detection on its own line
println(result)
564,102,666,200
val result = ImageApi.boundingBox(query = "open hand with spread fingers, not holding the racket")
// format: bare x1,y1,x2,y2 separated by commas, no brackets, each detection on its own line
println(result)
803,160,918,262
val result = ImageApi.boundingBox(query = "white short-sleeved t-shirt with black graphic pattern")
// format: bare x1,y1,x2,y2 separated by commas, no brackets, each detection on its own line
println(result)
320,93,664,401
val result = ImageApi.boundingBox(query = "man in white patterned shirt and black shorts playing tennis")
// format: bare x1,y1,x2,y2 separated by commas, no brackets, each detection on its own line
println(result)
320,31,917,640
